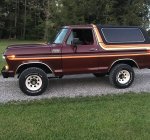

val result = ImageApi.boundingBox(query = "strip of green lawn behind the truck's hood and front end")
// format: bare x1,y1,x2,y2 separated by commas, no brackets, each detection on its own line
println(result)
0,40,40,70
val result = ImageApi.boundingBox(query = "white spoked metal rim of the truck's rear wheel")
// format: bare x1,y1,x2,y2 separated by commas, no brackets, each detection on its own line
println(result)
117,70,131,84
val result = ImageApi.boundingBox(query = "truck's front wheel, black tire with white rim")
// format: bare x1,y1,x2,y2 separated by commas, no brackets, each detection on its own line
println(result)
19,67,48,96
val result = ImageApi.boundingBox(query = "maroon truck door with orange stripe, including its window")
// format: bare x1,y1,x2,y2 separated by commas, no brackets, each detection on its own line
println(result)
62,28,99,74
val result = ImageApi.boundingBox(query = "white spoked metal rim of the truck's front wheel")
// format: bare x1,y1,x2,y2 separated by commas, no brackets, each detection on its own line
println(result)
25,75,42,91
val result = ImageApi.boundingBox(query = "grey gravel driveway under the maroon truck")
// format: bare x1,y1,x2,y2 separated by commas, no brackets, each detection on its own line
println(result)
0,69,150,103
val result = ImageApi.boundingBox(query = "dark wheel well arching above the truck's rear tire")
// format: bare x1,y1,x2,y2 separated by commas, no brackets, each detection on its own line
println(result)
109,60,139,72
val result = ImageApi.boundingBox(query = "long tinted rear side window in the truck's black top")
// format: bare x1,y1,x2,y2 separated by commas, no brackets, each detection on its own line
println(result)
101,28,145,43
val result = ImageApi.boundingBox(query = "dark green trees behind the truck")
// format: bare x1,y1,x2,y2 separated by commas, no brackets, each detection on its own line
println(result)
0,0,150,40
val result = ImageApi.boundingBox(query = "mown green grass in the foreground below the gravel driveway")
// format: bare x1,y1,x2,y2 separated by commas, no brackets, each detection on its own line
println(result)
0,94,150,140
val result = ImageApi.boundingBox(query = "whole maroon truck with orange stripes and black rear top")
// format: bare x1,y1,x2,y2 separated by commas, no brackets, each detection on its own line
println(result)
2,25,150,96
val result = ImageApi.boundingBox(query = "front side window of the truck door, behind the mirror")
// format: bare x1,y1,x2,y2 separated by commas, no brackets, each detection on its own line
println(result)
67,29,94,45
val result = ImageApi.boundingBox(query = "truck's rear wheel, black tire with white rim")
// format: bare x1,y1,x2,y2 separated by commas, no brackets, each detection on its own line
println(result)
109,64,134,88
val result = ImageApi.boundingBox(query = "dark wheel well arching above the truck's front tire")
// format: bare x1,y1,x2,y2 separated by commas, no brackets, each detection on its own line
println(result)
16,63,53,75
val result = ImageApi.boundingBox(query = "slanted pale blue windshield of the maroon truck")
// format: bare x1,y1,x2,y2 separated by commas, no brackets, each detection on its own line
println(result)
54,29,68,44
